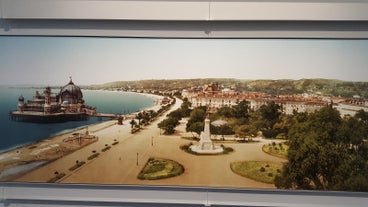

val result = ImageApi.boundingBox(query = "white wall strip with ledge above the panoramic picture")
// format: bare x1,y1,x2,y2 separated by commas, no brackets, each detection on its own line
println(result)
0,0,368,38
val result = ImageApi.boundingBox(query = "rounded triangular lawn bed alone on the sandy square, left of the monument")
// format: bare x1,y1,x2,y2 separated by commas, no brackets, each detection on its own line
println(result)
138,158,184,180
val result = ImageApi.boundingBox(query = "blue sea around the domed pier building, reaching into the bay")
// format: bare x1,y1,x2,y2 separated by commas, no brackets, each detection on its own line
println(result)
0,86,155,152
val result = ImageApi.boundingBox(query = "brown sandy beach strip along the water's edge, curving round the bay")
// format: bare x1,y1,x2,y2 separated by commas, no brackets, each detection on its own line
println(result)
0,90,163,181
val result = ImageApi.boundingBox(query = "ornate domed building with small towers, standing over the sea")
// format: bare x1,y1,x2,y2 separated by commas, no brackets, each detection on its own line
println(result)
11,78,96,122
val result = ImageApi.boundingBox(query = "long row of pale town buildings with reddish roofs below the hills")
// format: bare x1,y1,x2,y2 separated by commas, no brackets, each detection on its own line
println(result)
182,84,368,116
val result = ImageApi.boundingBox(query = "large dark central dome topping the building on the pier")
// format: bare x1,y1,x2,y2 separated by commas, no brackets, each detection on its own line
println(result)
60,79,83,104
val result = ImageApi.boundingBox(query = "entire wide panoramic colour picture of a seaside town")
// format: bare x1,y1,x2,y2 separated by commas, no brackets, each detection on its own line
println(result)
0,36,368,192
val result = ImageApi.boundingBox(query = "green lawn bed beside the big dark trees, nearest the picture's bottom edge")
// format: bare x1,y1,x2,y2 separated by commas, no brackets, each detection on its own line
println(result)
230,161,282,184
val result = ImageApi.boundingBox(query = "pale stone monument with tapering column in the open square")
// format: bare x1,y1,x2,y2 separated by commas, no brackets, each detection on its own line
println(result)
190,118,224,154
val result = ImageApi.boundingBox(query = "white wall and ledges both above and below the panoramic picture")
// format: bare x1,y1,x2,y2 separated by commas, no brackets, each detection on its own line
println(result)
0,0,368,207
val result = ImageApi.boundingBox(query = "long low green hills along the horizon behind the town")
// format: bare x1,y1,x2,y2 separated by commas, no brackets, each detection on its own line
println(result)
84,78,368,98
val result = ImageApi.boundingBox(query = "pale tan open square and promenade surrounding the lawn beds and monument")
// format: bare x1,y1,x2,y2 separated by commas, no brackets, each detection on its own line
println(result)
2,95,285,188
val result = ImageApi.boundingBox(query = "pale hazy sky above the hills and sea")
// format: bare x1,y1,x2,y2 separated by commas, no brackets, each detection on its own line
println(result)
0,36,368,86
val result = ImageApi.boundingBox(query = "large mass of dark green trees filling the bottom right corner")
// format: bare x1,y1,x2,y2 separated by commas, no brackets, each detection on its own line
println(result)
275,107,368,191
